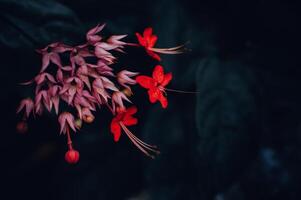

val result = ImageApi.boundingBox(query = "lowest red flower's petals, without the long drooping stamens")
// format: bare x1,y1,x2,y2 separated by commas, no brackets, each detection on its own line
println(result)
111,106,138,142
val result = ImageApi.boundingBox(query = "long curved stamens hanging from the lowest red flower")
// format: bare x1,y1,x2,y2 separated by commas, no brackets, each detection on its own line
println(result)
119,122,160,159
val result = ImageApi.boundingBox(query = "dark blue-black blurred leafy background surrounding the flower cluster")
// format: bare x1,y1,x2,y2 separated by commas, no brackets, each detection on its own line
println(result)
0,0,301,200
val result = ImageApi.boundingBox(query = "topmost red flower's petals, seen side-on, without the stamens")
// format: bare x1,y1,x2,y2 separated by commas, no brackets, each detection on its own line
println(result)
136,27,161,61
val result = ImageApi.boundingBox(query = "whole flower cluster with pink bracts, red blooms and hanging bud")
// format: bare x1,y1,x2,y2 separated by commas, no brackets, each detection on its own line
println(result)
17,25,183,164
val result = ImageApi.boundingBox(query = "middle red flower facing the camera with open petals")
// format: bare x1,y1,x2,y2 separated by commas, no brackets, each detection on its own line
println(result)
136,65,172,108
